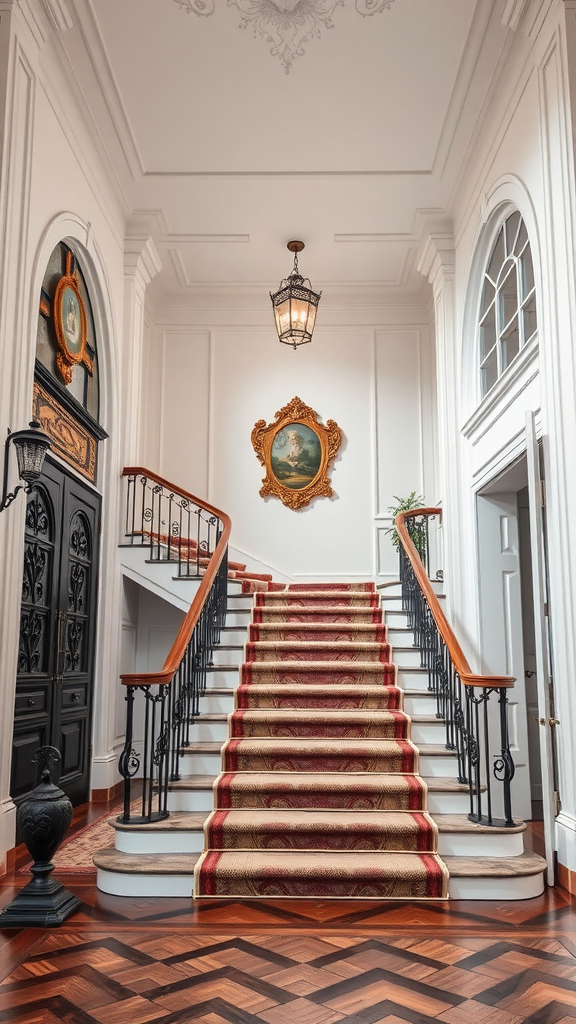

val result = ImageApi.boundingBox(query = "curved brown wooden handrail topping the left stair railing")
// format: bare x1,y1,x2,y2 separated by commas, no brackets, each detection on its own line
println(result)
120,466,232,686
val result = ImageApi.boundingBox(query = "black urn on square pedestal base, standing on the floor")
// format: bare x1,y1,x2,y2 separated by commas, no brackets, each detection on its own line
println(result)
0,746,80,928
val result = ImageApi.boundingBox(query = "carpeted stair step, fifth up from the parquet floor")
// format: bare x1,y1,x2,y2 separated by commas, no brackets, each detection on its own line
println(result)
230,708,410,739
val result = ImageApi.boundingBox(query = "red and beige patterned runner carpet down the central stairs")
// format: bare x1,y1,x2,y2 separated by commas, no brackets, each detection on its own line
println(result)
195,584,448,899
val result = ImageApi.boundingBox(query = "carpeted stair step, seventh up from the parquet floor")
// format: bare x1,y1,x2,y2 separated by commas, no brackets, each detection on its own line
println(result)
240,660,396,686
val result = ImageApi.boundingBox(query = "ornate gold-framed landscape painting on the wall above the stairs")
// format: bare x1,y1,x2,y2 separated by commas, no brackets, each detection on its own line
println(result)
252,397,342,511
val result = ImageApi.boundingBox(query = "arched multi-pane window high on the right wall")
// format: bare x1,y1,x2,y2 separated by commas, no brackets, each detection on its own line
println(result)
479,210,537,397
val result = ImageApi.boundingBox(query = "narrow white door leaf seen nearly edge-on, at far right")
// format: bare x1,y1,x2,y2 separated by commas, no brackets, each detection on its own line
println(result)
526,411,554,886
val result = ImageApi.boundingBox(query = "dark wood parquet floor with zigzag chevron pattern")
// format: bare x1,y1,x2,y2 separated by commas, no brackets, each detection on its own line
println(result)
0,815,576,1024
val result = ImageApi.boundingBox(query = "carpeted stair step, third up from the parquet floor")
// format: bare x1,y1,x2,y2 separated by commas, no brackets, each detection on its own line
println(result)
212,771,426,811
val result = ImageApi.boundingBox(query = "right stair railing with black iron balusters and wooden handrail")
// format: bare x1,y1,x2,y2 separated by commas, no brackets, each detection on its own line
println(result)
396,508,516,827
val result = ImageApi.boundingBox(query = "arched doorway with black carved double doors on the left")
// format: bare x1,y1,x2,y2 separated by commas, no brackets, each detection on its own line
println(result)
11,243,107,805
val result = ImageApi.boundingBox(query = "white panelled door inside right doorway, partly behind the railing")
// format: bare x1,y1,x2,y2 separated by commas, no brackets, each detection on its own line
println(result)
477,492,532,818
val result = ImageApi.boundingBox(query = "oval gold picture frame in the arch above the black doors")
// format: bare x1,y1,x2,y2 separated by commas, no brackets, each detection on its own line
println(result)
53,253,92,384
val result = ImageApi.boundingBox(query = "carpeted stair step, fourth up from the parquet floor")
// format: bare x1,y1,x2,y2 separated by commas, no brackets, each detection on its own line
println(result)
220,738,418,773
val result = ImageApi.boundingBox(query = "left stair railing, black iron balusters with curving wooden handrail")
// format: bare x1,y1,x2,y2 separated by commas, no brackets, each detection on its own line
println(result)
118,467,232,824
